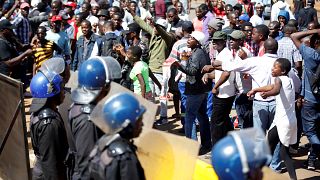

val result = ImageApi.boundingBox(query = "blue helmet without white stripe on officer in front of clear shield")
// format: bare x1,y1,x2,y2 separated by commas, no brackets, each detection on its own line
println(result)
91,93,146,135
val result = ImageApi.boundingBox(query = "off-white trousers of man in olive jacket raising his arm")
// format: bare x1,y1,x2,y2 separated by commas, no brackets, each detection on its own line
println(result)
149,73,169,117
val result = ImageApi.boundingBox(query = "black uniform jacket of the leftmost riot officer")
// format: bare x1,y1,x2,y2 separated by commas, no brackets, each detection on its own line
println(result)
30,108,68,180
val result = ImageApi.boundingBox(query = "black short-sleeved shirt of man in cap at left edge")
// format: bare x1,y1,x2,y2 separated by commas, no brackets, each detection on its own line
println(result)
0,38,18,76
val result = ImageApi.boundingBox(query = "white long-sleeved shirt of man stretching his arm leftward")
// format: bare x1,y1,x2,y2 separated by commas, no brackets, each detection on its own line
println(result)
222,53,277,101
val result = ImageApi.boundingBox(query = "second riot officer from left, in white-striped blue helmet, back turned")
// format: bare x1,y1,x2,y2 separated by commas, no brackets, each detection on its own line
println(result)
68,57,121,179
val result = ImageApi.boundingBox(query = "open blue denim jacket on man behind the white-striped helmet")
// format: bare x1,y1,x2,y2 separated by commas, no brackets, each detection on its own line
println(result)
71,33,102,71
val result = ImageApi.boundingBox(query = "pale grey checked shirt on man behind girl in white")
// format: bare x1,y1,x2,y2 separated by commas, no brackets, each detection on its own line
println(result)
278,37,302,68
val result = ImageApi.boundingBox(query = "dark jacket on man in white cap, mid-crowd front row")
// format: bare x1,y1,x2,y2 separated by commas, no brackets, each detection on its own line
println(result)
179,47,212,95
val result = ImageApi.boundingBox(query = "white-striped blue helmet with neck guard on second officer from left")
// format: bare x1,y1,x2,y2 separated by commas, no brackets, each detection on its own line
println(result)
71,57,121,104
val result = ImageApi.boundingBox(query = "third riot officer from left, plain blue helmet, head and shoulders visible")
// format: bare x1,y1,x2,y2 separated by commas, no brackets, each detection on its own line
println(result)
89,93,146,180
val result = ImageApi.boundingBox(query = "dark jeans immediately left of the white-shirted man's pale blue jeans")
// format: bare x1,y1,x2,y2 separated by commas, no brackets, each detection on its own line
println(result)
235,94,253,129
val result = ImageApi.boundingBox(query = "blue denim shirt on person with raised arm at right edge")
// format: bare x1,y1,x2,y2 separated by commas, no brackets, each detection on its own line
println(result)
299,44,320,103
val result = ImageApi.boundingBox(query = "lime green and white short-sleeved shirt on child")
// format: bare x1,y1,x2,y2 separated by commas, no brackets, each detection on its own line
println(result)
129,61,151,95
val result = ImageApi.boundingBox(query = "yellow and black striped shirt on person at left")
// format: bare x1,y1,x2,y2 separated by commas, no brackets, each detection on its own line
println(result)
32,41,57,71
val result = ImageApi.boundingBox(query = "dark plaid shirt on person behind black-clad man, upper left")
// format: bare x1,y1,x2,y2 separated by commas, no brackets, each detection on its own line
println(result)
12,13,31,44
